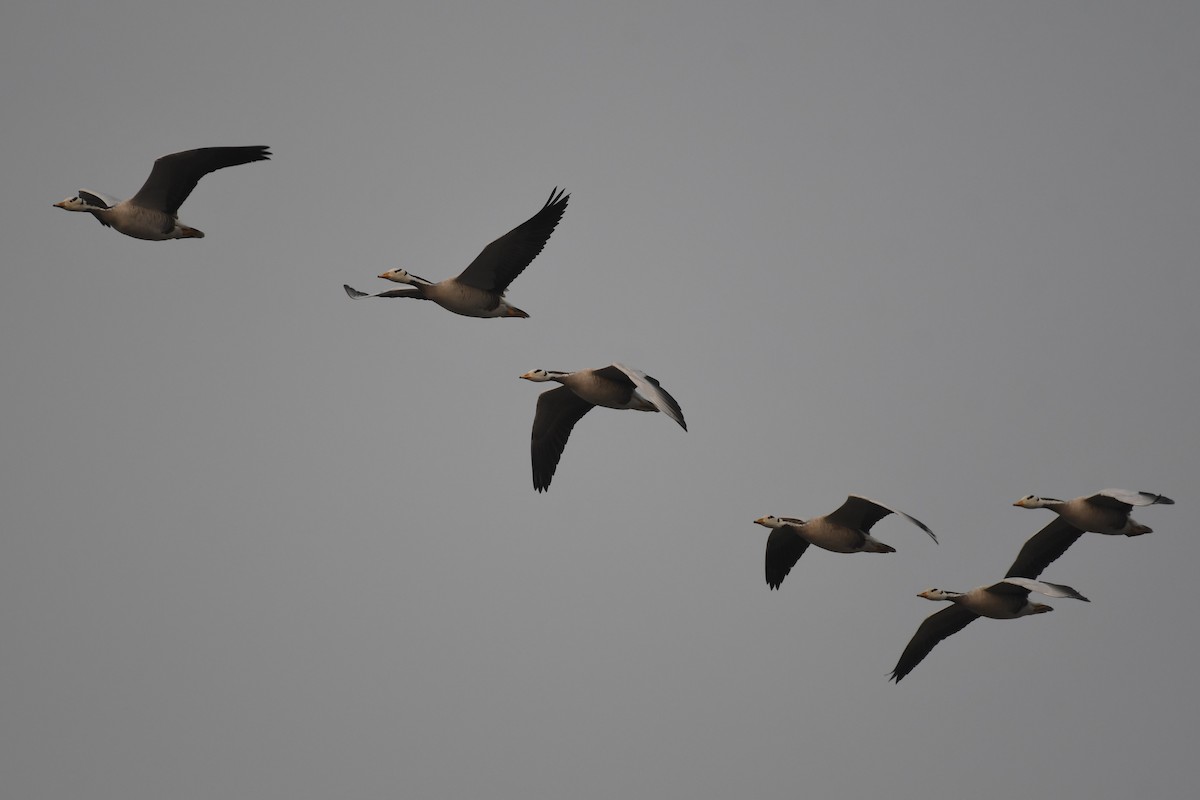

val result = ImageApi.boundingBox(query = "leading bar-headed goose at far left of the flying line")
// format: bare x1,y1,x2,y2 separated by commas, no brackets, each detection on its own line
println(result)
54,145,271,241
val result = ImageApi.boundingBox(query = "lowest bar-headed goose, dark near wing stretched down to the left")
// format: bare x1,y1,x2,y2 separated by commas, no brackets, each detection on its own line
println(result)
892,577,1091,684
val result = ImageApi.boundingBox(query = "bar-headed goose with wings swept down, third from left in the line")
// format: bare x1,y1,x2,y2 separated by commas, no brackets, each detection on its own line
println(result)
521,363,688,492
